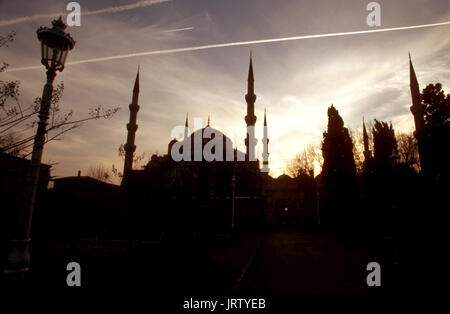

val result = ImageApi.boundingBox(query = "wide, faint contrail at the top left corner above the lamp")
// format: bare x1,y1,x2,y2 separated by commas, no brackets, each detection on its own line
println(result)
0,0,170,27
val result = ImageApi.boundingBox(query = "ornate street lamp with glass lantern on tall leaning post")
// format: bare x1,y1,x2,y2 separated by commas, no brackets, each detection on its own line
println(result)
5,17,75,273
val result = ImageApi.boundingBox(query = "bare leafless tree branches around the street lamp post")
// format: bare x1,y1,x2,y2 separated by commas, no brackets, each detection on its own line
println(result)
0,32,119,157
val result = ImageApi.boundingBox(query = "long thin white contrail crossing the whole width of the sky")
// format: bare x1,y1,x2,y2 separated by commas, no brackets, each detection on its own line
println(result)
5,21,450,72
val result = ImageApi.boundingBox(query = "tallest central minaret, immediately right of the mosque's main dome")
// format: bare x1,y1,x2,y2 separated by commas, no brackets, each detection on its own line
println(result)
245,52,256,161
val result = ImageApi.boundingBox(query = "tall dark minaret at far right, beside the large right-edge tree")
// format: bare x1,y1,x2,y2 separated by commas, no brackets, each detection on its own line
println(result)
409,54,425,172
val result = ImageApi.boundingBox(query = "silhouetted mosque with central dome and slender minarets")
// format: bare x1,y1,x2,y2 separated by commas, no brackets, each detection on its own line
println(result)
122,55,315,239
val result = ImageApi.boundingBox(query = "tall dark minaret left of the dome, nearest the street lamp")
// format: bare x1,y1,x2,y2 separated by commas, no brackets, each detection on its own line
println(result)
123,67,139,177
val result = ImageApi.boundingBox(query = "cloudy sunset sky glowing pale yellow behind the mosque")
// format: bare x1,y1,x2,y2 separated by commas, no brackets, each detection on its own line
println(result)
0,0,450,177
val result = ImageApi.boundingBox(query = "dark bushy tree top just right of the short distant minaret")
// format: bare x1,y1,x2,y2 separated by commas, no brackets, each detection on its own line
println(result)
372,119,398,169
